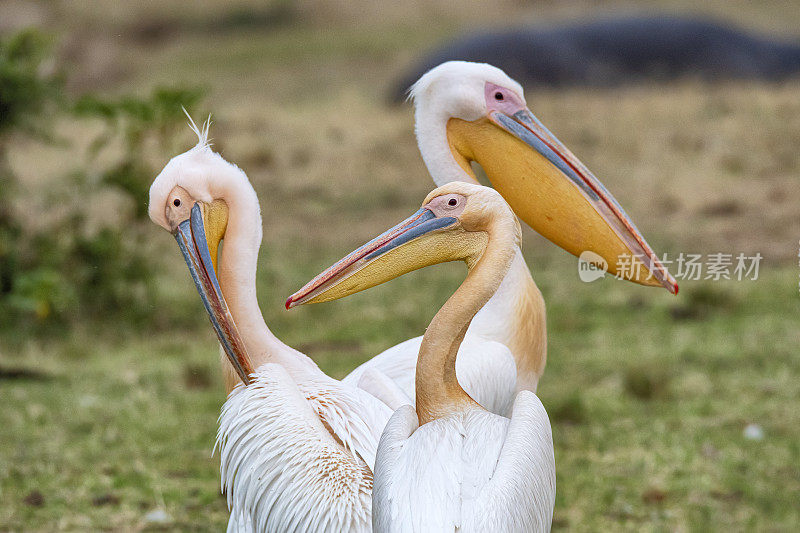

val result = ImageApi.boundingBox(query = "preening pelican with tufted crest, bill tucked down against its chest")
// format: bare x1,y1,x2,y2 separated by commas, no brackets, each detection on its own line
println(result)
149,121,392,532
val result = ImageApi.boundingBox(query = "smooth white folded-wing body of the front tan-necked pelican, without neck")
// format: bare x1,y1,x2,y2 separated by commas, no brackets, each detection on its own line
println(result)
373,391,556,533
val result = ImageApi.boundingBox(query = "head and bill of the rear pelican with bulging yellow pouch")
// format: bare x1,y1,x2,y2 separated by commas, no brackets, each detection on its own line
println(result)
410,61,678,294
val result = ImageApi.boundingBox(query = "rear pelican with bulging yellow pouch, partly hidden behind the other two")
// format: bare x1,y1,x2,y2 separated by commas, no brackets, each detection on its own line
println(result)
318,61,678,414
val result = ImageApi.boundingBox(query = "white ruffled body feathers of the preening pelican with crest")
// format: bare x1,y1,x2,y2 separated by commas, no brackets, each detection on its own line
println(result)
216,364,388,532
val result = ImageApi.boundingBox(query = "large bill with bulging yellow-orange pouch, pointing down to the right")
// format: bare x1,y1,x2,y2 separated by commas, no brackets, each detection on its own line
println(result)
447,105,678,294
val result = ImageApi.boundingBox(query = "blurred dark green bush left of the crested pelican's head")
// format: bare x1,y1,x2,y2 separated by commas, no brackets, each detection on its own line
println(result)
0,31,200,332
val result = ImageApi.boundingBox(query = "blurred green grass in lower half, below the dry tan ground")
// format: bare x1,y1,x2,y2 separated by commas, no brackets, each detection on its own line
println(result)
0,260,800,531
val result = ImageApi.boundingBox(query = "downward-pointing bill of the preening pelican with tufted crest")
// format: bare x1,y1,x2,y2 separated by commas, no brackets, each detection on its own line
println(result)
174,200,253,385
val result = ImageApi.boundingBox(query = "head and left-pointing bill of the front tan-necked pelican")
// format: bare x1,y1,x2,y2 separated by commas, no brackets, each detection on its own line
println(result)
286,181,521,309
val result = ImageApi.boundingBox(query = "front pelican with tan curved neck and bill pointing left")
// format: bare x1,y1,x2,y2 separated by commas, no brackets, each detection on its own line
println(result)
288,182,555,532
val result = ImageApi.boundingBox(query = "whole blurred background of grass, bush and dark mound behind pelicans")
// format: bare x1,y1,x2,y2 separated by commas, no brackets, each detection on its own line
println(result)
0,0,800,531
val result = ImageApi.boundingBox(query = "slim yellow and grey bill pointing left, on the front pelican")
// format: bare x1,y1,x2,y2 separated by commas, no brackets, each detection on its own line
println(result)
286,207,478,309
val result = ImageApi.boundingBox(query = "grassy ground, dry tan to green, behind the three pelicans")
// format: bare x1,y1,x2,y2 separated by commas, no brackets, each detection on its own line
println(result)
0,1,800,531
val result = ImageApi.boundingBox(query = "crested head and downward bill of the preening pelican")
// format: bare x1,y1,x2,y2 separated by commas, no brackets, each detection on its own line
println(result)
148,122,253,384
